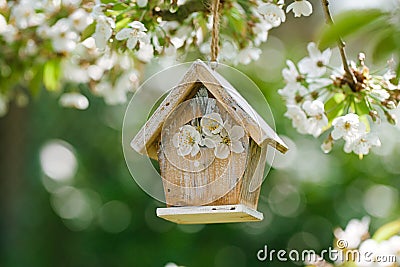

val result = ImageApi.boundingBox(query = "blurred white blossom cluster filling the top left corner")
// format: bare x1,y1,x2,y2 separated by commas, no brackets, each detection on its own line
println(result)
0,0,139,116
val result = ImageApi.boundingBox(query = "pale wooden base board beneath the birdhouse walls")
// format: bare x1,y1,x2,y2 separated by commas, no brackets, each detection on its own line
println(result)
156,204,264,224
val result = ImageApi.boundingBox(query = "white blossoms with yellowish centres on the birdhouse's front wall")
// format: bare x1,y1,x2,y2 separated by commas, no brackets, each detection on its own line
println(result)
172,112,245,159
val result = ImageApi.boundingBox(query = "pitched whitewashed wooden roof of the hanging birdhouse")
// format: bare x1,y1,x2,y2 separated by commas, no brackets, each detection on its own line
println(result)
131,60,288,159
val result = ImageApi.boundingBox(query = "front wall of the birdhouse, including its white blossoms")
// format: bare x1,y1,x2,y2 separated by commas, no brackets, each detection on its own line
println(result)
158,83,249,206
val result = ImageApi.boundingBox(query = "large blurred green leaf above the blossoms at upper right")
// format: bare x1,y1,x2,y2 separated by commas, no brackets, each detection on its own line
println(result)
319,9,386,49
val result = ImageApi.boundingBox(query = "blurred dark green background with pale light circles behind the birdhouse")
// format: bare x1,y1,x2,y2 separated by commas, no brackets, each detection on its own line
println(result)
0,1,400,267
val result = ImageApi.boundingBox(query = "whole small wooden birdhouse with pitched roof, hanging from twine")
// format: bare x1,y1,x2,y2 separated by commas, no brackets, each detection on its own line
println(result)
131,61,287,224
